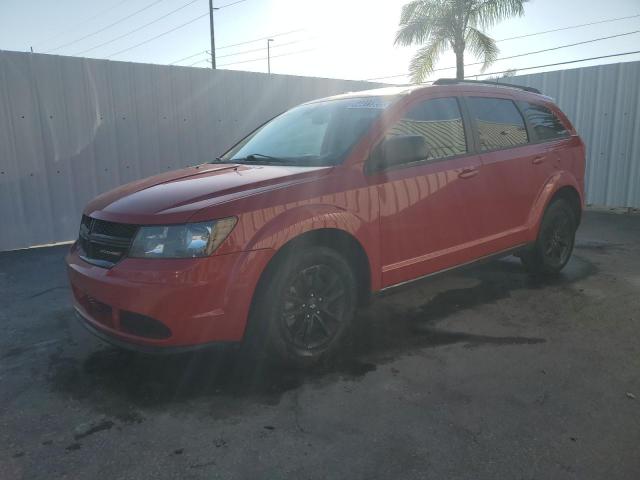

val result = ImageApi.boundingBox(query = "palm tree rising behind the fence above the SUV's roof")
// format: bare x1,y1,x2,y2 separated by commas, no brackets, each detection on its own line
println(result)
395,0,529,83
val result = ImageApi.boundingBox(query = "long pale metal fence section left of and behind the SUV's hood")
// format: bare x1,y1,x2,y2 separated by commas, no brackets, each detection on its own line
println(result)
0,51,372,251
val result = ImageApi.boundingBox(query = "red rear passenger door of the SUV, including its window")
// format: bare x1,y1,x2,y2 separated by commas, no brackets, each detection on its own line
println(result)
465,94,545,244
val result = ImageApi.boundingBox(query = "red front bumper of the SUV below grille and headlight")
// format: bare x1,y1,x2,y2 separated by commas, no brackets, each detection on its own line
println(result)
66,245,272,352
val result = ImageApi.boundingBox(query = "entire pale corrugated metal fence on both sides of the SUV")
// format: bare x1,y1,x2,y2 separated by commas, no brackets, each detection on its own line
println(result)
0,51,640,251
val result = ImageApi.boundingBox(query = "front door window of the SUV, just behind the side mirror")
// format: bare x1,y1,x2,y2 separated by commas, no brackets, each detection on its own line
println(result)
387,97,467,160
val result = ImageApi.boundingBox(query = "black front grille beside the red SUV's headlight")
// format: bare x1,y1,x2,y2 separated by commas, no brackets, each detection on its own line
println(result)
78,215,138,268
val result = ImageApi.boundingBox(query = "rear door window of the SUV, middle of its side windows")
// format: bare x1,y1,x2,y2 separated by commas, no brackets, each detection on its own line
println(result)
466,97,529,151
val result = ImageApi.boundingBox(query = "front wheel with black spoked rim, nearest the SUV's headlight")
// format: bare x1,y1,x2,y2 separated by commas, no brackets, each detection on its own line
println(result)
244,246,358,368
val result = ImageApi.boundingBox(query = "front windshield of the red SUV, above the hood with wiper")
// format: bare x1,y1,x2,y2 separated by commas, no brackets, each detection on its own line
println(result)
218,97,393,166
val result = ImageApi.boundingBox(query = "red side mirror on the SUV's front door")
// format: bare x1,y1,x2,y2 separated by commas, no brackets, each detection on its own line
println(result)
367,135,429,173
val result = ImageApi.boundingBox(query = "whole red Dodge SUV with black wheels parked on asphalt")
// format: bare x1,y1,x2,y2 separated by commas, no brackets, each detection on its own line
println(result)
67,80,585,365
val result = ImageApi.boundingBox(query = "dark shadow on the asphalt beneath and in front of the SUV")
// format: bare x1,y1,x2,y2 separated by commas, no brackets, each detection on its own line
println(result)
48,256,596,418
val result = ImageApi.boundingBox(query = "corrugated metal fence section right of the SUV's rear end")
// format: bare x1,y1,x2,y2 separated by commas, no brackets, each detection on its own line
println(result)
505,62,640,208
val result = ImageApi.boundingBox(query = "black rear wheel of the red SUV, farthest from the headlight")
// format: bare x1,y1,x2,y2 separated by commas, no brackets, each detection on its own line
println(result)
520,198,577,276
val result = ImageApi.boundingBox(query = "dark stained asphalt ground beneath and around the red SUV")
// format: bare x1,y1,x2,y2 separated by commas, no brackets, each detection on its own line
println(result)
0,212,640,480
